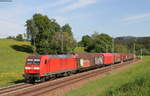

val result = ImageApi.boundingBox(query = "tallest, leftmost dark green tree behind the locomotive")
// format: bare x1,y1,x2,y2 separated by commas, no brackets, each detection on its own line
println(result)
26,14,60,54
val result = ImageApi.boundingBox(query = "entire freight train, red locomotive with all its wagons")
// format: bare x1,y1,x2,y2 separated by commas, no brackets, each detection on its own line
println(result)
24,53,134,82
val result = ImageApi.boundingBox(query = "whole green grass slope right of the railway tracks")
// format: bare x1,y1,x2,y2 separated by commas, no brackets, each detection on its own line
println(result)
65,56,150,96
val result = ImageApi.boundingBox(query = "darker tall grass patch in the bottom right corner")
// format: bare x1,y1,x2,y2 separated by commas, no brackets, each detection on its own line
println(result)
106,73,150,96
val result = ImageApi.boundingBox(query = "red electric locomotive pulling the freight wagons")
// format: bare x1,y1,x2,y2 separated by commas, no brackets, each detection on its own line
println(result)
24,55,77,82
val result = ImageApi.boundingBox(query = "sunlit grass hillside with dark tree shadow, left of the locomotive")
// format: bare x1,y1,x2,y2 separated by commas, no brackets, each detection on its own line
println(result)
0,39,31,87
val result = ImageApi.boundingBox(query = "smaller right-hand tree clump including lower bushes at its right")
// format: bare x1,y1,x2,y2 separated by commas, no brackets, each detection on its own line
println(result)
79,32,128,53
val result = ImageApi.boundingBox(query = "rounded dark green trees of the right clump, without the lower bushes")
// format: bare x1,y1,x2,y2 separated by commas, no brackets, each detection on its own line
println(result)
81,32,112,52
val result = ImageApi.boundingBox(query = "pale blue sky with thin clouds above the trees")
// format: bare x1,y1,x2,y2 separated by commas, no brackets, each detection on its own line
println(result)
0,0,150,40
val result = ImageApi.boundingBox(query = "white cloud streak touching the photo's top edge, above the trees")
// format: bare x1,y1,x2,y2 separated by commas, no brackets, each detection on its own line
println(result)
61,0,96,12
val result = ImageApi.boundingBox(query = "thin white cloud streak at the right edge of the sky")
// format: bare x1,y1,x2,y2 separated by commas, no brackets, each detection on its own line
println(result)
123,13,150,22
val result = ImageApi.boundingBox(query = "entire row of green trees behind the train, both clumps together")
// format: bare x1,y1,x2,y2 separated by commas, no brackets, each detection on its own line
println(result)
18,14,146,54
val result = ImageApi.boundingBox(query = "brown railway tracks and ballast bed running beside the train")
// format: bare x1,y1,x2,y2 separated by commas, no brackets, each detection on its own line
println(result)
0,61,140,96
